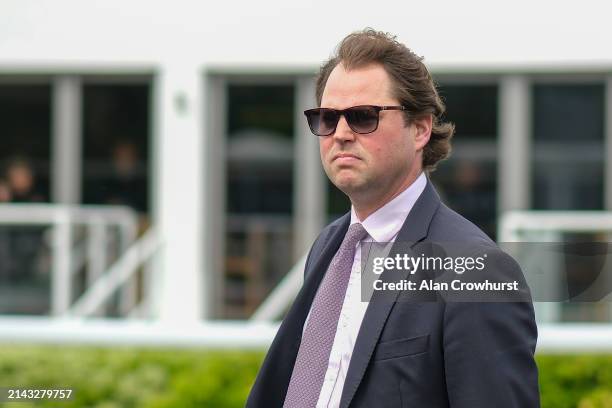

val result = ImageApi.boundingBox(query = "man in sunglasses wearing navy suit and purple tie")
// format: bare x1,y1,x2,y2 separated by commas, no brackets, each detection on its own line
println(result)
247,29,539,408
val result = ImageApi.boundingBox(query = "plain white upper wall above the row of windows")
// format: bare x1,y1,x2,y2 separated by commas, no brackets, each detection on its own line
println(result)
0,0,612,69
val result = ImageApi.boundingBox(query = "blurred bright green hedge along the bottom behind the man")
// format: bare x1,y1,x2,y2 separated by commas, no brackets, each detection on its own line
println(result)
0,344,612,408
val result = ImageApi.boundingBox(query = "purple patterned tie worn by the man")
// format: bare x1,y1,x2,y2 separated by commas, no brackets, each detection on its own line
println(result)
283,223,368,408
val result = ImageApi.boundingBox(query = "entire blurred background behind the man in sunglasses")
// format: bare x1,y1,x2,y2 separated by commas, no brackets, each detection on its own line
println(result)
0,0,612,408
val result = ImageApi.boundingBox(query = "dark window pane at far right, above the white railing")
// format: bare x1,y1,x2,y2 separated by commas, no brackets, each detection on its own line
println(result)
531,84,604,210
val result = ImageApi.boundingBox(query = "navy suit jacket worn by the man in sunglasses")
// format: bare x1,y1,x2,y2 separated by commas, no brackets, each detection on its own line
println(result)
247,181,540,408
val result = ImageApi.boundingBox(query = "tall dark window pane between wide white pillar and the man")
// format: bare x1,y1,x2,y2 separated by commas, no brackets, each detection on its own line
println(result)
225,83,295,318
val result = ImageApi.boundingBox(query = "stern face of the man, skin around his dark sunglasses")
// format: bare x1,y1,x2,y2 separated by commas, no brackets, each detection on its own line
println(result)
319,64,427,205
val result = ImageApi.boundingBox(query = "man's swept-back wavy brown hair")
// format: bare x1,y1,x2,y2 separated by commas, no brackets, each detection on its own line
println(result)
316,28,455,172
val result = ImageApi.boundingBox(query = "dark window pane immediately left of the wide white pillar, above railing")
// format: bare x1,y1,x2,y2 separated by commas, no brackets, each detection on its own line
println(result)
83,83,150,213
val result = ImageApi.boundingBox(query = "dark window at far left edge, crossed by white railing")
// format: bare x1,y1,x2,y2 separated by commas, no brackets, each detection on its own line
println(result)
0,82,51,314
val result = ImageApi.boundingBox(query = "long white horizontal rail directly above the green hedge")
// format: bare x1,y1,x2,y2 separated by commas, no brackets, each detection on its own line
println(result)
0,316,612,354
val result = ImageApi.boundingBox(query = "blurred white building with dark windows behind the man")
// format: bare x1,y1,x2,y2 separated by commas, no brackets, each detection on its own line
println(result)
0,0,612,328
